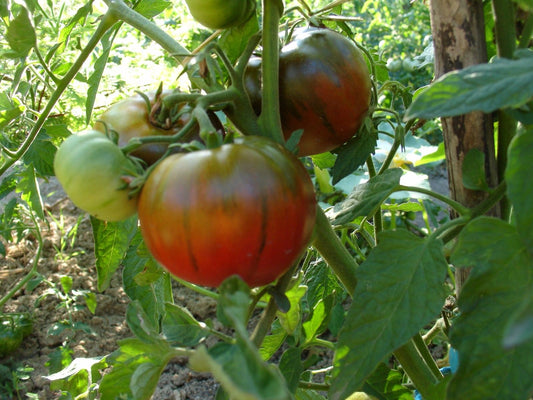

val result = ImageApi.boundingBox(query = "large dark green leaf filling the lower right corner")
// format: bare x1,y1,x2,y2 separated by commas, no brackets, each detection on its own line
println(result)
448,217,533,400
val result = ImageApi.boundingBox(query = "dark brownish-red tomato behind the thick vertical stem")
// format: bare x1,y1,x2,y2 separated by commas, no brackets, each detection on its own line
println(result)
245,29,372,156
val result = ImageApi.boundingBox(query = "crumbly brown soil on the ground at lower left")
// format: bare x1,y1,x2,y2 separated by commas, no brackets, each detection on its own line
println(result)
0,180,217,400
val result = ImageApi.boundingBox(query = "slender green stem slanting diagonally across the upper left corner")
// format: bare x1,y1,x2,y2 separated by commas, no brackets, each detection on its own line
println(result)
0,14,117,176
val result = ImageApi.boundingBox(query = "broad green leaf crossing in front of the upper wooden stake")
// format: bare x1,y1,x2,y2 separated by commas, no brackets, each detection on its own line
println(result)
405,52,533,120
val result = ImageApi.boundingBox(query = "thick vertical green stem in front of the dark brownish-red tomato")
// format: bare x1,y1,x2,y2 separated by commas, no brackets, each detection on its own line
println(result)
259,0,285,144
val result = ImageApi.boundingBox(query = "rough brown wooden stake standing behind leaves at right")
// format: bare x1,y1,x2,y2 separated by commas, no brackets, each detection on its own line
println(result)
430,0,498,293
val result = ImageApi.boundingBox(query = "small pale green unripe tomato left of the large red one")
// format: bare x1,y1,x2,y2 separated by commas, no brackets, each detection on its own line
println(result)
54,130,137,221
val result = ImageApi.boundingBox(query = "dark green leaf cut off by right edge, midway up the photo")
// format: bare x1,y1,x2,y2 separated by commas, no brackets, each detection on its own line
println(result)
505,127,533,253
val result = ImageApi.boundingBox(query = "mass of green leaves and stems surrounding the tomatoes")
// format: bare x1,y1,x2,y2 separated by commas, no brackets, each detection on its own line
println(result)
0,0,533,400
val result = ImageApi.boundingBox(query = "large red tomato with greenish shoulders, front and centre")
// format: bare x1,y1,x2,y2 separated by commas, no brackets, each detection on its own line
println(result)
138,136,316,287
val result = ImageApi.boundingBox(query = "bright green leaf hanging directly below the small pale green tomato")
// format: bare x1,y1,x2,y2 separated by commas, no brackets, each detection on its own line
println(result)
91,217,137,291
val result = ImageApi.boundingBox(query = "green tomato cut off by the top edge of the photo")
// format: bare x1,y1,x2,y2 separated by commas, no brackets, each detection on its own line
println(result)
186,0,255,29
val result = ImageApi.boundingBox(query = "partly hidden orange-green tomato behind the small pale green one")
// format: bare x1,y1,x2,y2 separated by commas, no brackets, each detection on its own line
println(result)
93,90,224,165
